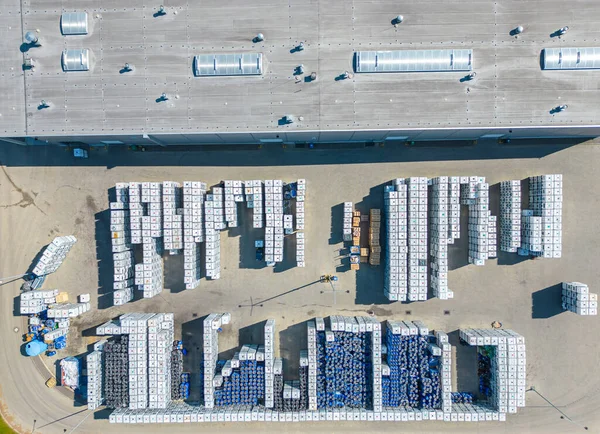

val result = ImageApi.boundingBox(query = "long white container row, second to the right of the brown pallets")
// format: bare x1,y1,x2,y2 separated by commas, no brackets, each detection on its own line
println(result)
396,177,428,301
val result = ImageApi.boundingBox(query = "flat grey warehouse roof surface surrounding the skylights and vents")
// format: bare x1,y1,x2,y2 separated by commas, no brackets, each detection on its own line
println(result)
0,0,600,136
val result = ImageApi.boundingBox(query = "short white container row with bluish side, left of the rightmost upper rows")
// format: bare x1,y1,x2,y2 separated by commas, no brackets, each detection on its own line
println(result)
500,180,521,253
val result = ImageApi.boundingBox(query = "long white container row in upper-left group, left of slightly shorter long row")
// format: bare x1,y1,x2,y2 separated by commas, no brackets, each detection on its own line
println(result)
182,181,206,289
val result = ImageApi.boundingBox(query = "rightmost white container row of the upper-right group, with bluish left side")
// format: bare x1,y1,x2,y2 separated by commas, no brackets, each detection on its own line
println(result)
529,174,563,258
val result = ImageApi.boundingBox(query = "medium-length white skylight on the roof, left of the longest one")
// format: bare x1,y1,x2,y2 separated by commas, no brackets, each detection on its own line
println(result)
194,53,263,76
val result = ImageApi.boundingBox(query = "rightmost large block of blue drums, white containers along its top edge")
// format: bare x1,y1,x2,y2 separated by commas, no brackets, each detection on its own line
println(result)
382,321,441,409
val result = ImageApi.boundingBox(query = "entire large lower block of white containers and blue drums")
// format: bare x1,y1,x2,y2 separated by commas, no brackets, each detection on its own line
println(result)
88,313,526,423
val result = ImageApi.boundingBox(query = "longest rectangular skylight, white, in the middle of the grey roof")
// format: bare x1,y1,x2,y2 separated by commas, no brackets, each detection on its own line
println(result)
354,49,473,72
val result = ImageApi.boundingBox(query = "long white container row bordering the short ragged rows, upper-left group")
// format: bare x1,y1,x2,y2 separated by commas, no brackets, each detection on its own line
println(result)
204,194,223,280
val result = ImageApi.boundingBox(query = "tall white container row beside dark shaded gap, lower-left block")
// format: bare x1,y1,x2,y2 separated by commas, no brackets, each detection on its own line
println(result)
148,313,179,408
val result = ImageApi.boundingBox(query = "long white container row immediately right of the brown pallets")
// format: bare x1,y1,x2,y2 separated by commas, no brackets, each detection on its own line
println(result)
383,182,408,301
